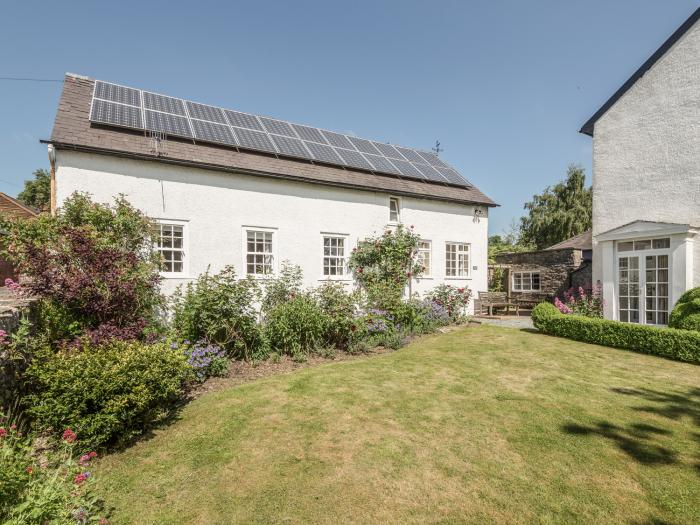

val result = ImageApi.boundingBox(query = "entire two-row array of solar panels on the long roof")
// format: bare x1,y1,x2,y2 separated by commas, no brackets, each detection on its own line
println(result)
90,80,471,187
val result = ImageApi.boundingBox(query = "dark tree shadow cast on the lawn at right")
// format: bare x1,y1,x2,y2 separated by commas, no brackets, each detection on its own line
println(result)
562,388,700,466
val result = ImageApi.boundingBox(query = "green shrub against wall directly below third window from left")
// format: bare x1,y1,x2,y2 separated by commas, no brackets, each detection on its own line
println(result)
314,281,363,350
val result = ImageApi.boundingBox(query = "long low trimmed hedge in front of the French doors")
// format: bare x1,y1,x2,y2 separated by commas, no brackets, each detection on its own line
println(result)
532,303,700,363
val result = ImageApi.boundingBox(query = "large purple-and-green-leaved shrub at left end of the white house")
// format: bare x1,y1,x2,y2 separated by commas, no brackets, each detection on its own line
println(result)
1,193,163,342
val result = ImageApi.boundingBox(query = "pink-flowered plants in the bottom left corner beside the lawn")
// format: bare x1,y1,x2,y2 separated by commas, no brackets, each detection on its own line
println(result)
0,413,107,525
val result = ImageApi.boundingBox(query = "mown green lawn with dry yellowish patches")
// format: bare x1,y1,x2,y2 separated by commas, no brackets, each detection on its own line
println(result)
97,326,700,524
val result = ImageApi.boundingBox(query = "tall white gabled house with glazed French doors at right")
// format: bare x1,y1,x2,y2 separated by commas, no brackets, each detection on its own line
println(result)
581,9,700,325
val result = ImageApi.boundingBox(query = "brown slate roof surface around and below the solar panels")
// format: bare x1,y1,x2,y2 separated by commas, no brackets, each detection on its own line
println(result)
45,74,497,206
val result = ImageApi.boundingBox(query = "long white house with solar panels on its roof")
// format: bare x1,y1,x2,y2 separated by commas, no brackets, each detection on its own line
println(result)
47,74,495,304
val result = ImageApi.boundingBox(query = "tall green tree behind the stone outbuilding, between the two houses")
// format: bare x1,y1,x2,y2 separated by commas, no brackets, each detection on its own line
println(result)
520,165,593,250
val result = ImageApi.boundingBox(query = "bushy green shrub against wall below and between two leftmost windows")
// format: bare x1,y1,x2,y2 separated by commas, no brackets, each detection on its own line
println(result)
171,266,267,359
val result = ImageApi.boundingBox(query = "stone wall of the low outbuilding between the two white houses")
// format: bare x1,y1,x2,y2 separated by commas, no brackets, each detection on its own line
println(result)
495,248,591,302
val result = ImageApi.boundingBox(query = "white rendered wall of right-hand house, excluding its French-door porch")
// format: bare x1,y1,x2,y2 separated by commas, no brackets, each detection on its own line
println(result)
593,20,700,310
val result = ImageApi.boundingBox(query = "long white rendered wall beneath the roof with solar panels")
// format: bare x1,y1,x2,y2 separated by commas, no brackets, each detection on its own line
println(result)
56,150,488,310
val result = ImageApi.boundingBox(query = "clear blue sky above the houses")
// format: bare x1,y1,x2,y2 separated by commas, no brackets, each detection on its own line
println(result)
0,0,699,233
